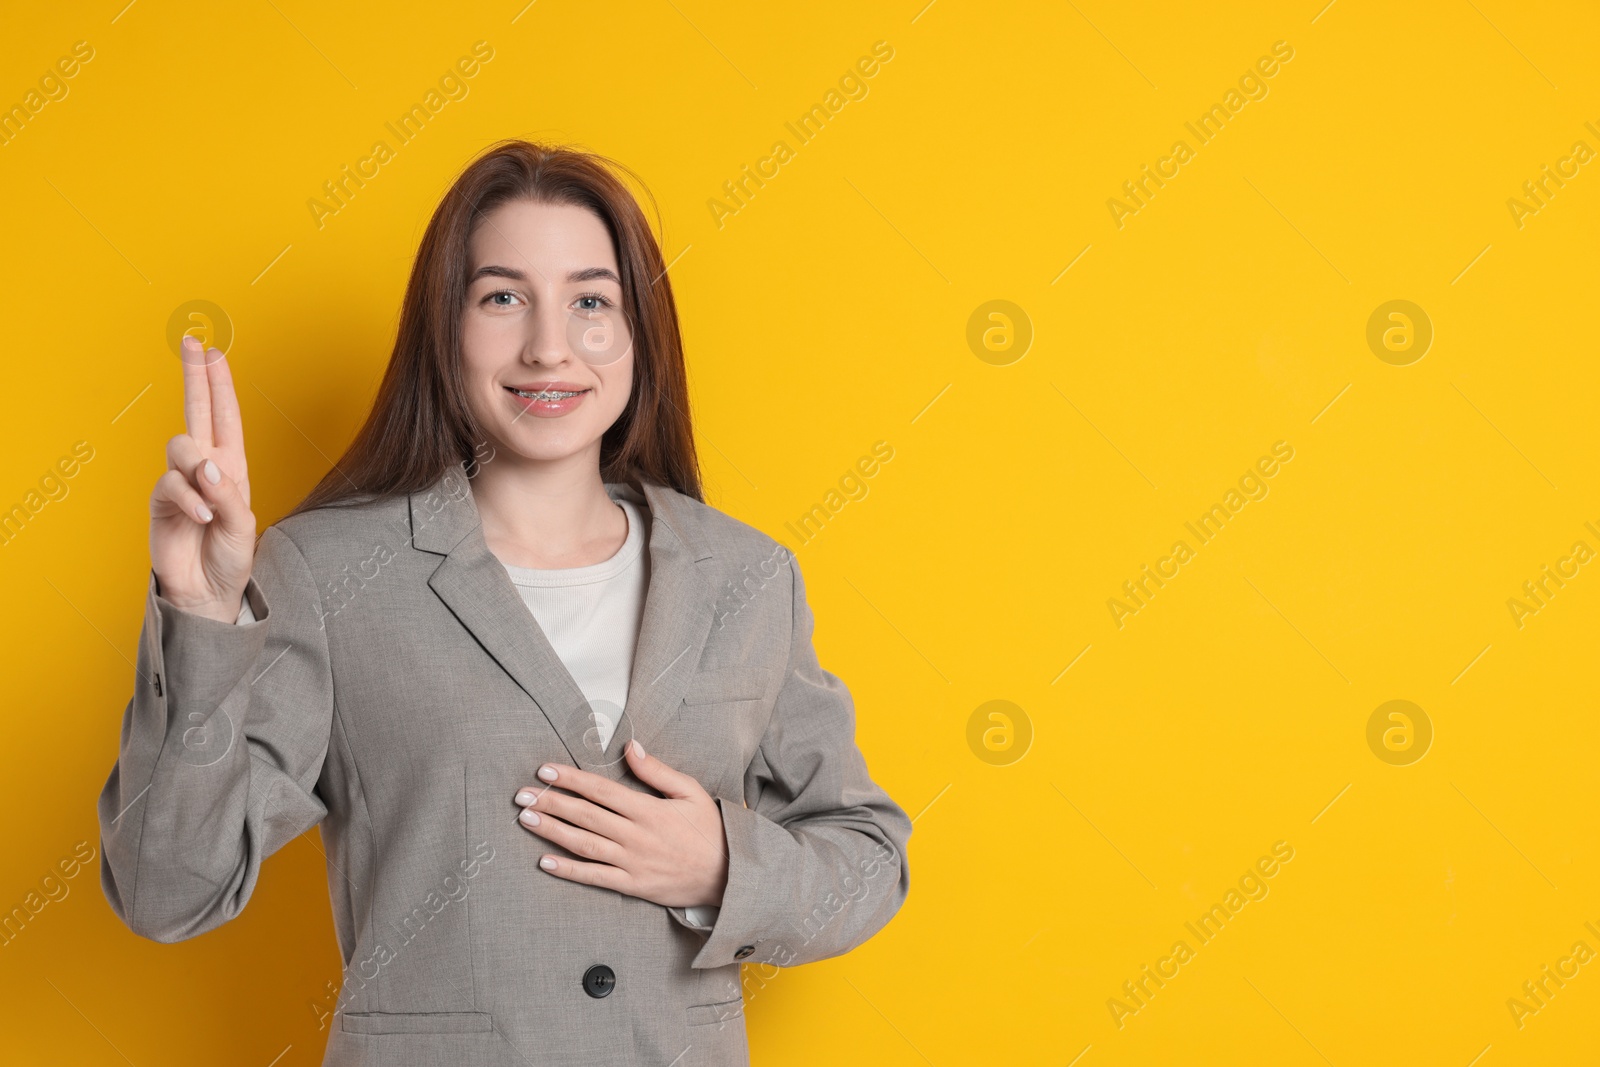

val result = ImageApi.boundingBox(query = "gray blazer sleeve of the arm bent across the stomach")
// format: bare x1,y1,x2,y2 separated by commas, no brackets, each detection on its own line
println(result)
691,553,912,968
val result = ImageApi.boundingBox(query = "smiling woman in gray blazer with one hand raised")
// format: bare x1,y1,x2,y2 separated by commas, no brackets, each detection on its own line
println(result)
99,141,910,1067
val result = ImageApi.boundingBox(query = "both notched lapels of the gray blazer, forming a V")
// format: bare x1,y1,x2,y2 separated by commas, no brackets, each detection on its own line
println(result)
410,469,715,779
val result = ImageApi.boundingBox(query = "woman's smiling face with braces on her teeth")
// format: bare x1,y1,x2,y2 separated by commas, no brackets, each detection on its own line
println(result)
461,200,634,466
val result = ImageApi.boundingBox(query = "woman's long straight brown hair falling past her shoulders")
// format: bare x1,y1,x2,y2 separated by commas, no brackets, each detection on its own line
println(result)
290,141,704,515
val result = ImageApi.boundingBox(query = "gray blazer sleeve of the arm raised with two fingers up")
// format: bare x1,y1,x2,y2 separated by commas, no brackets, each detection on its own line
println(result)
99,526,333,942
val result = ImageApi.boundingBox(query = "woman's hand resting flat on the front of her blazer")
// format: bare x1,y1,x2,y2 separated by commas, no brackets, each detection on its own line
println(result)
517,741,728,907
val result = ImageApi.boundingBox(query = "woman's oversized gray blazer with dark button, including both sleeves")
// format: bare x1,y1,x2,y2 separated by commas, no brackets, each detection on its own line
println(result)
99,470,910,1067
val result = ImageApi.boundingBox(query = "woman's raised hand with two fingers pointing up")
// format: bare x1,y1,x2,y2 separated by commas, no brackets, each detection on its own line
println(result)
150,338,256,622
